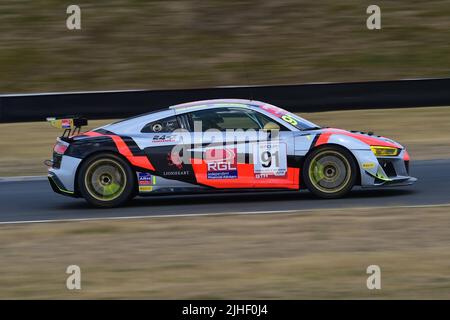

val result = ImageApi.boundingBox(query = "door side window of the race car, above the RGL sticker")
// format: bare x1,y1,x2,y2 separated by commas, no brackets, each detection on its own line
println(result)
190,108,262,131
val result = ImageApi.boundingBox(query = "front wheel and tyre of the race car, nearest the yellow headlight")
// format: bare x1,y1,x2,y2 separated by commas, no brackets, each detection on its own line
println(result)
302,145,358,199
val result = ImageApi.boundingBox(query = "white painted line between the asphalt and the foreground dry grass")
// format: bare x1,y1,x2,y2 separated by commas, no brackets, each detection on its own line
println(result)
0,203,450,226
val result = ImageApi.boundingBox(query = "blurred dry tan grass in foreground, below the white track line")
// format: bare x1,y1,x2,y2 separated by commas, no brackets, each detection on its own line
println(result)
0,207,450,299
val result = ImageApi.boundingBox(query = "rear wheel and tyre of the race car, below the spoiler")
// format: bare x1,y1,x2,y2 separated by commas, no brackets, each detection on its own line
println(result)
77,153,136,208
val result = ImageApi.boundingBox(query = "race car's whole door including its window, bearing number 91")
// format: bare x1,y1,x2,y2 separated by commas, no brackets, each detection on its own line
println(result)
185,108,298,189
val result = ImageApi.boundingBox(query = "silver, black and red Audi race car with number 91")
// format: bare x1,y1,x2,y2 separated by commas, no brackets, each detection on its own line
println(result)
47,99,416,207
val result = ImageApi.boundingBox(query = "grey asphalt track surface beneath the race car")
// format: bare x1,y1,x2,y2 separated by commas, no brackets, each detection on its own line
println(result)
0,160,450,224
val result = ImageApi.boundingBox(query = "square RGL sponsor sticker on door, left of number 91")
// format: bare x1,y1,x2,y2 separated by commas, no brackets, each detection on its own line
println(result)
205,149,238,179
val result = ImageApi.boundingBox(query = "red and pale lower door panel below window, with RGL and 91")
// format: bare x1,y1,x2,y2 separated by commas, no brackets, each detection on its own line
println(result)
191,132,299,189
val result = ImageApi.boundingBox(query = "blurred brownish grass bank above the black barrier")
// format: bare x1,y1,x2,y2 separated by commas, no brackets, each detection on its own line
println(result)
0,0,450,93
